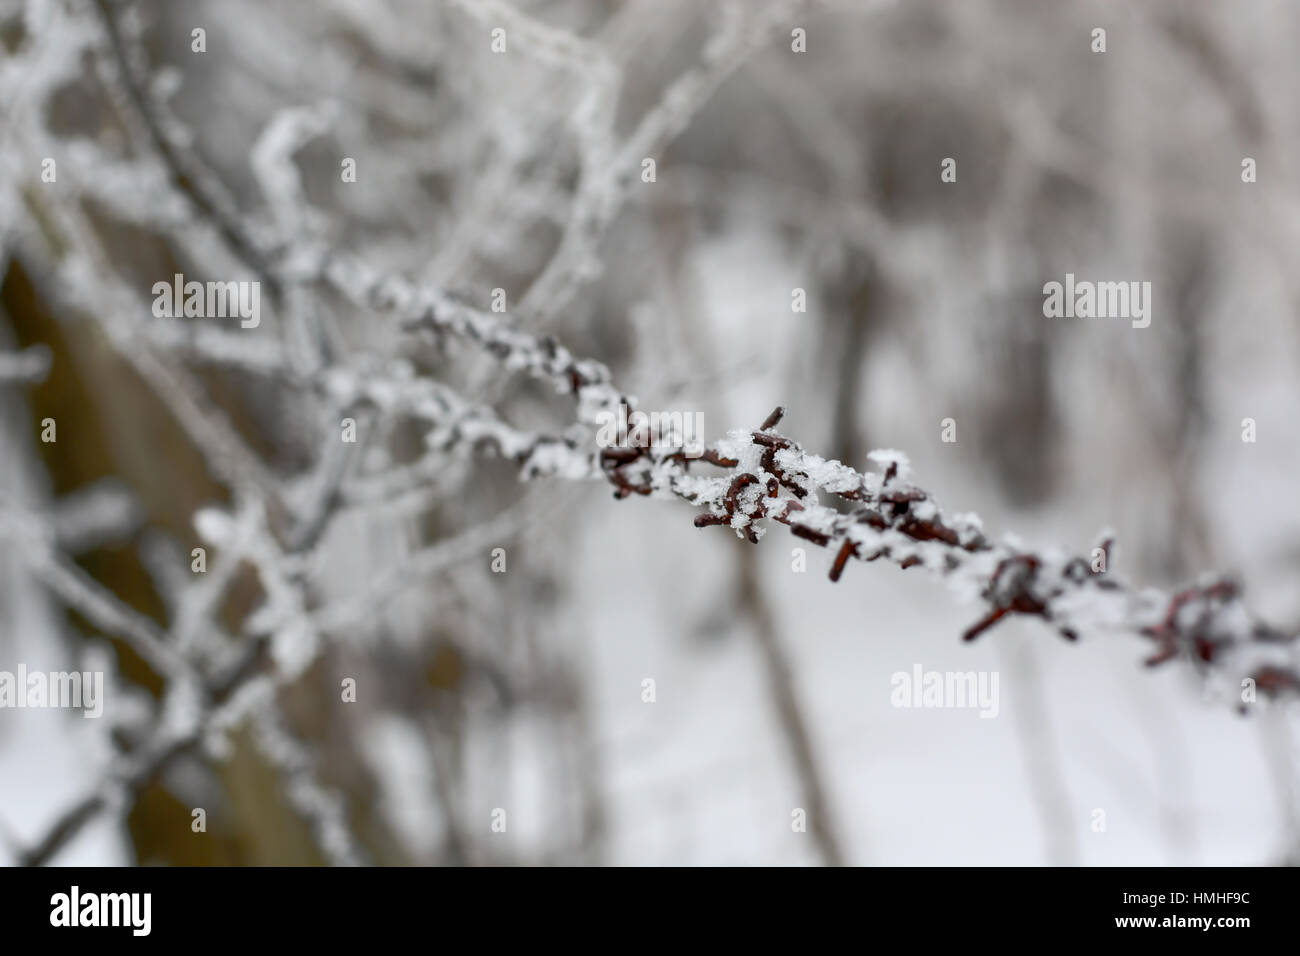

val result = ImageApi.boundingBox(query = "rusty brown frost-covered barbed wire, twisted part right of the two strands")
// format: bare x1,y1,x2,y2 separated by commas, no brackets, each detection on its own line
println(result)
587,407,1300,696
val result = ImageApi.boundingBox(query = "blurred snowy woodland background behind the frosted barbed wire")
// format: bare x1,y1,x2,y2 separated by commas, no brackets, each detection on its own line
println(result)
0,0,1300,865
